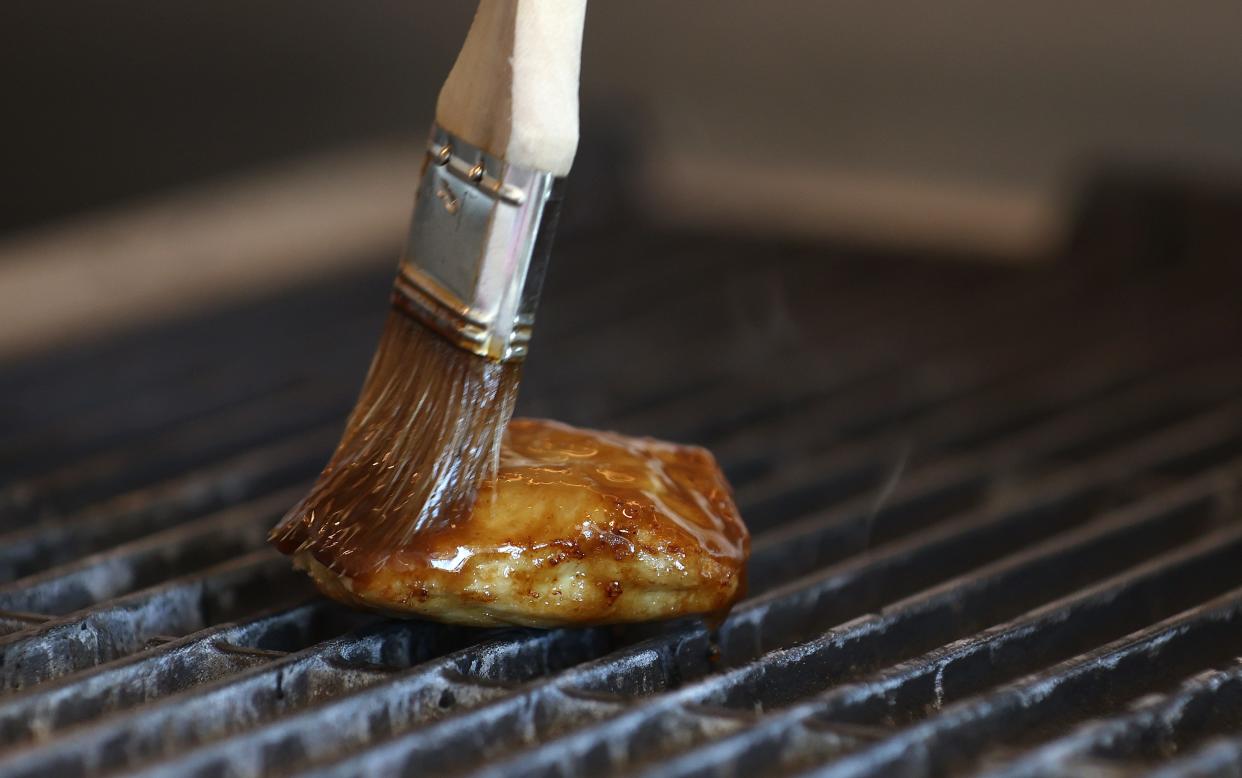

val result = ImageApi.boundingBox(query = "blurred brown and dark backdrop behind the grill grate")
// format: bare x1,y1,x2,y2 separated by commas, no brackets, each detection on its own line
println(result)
0,0,1242,354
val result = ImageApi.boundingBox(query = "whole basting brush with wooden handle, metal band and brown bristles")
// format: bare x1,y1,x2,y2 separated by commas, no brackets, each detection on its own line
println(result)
271,0,586,573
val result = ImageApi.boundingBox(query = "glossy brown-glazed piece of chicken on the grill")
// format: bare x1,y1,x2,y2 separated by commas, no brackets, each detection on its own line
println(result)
278,419,749,626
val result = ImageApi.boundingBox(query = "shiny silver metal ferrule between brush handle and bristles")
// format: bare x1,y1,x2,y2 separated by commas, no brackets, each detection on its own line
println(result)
392,127,564,362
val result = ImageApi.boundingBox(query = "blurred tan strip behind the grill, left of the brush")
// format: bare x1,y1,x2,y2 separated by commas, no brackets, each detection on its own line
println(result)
0,145,421,359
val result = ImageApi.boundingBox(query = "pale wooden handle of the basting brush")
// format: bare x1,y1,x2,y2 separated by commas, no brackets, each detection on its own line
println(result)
436,0,586,175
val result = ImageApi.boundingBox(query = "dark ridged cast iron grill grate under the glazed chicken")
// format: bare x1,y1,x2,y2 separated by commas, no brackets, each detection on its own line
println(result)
0,208,1242,777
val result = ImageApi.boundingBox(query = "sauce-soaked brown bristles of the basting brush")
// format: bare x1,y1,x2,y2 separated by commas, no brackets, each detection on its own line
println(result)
271,309,520,574
